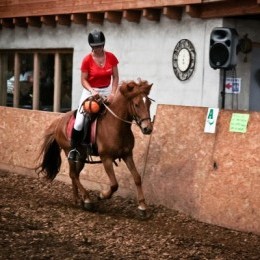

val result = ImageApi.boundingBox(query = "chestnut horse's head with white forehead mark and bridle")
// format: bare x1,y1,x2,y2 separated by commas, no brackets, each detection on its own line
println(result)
120,80,153,135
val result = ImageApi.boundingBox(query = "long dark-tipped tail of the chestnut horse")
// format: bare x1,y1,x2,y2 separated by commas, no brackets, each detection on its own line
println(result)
36,132,61,181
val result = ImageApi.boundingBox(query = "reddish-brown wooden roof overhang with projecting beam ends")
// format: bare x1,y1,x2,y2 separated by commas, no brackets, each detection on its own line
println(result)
0,0,260,28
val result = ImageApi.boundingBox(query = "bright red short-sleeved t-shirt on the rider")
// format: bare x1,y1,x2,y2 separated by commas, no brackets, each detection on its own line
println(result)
81,51,118,88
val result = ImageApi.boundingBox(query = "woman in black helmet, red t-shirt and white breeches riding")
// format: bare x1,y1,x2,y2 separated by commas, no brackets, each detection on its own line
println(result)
68,29,119,161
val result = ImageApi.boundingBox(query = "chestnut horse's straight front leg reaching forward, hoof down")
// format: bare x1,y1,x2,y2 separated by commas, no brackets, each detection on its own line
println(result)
123,155,147,213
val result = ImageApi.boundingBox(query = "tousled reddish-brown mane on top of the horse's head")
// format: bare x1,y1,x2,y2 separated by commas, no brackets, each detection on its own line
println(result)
119,79,153,99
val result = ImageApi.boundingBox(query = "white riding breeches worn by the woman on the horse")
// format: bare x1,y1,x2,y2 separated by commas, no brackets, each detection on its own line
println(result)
74,87,111,131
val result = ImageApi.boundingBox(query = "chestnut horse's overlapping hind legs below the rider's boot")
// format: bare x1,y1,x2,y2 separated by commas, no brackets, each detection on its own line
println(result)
69,161,92,209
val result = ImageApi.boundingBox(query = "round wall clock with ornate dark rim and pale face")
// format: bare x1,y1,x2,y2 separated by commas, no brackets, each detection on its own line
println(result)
172,39,196,81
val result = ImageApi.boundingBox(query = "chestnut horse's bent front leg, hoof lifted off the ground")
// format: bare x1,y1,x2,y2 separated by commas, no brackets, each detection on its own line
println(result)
100,157,118,199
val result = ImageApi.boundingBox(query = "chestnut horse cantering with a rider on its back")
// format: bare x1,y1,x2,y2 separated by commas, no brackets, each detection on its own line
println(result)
36,79,153,216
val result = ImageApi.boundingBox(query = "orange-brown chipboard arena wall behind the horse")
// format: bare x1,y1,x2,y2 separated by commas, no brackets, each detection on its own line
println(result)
0,105,260,234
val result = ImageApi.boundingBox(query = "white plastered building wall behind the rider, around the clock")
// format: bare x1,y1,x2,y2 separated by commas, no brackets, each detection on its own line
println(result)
0,15,258,112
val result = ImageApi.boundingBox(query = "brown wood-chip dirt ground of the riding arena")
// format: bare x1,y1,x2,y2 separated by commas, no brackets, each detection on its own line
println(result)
0,172,260,260
